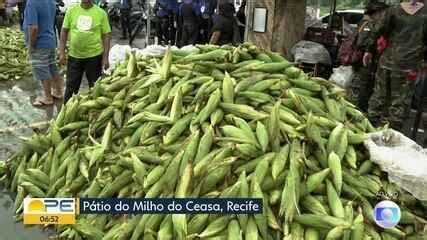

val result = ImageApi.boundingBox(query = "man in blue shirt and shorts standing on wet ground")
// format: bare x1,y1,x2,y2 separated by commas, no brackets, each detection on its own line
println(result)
23,0,62,106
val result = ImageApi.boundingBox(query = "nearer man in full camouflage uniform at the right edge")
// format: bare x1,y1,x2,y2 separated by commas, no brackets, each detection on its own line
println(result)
363,0,427,131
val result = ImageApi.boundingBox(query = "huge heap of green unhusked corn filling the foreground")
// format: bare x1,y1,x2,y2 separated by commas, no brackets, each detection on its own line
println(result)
0,44,427,240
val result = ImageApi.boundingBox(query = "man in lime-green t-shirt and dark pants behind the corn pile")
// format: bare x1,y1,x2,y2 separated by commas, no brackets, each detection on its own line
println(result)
59,0,111,102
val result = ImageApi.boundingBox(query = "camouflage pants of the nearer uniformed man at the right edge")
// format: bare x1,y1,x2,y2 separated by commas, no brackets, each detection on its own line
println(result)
368,67,414,131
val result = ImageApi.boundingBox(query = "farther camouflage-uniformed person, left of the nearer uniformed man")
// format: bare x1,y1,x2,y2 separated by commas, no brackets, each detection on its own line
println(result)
349,2,388,112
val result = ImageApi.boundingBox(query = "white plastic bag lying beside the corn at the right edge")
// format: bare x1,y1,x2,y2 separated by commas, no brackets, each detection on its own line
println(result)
364,129,427,201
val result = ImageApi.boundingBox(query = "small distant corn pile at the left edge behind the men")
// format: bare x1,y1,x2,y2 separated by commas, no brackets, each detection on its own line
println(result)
0,28,31,81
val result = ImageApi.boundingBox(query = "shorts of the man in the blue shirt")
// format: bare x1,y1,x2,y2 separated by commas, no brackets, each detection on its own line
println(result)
30,48,59,81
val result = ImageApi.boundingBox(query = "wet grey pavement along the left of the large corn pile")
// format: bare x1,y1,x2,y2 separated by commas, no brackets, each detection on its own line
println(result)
0,77,61,240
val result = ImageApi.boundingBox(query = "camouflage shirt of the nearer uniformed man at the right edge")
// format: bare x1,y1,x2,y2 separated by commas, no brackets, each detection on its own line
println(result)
369,6,427,71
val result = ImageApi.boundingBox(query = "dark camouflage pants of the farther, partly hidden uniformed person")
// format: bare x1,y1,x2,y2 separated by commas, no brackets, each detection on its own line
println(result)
348,67,375,112
